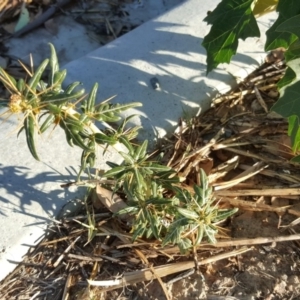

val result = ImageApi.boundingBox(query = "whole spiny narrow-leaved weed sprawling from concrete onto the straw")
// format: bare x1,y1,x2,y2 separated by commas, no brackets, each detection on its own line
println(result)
0,44,237,252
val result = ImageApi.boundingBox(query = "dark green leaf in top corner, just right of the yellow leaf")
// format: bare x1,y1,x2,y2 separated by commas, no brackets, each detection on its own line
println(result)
265,0,300,51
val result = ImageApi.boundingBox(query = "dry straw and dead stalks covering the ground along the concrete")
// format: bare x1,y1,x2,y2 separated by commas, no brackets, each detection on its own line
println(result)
0,52,300,300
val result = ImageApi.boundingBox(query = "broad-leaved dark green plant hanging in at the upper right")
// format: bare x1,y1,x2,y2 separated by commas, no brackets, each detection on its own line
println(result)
202,0,300,161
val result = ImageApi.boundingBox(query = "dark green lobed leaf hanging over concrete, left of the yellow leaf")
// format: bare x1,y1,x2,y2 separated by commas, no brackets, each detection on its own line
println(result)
202,0,260,73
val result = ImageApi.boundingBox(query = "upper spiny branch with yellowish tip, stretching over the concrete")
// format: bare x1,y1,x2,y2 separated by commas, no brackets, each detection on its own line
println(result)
0,44,141,174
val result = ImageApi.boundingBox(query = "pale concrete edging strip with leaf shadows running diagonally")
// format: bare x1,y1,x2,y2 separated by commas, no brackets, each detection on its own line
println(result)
0,0,274,280
